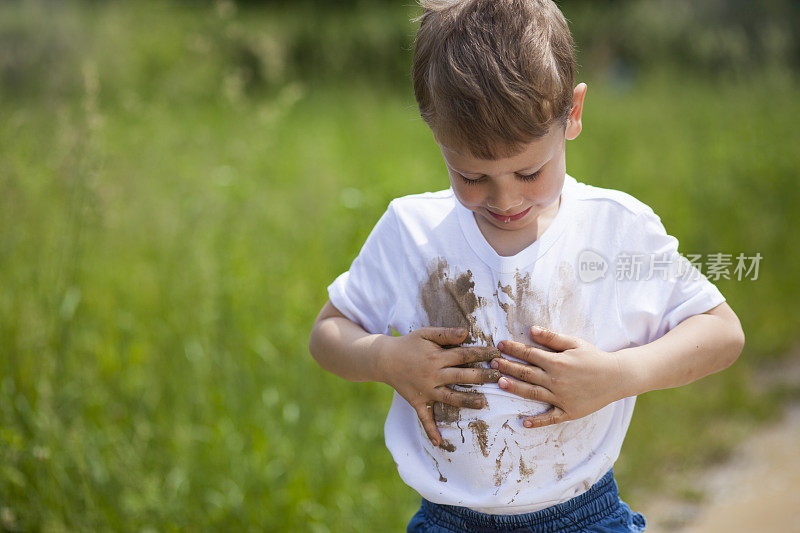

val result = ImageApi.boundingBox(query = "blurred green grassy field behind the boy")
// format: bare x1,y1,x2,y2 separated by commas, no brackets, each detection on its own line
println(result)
0,2,800,531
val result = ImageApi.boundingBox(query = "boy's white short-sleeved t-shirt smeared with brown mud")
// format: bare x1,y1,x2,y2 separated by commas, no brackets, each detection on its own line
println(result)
328,176,725,514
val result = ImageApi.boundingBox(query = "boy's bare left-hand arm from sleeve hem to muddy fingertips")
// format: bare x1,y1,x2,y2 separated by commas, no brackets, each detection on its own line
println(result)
308,301,500,446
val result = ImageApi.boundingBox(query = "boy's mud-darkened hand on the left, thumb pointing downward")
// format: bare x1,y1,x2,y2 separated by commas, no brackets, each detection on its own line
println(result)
379,327,500,446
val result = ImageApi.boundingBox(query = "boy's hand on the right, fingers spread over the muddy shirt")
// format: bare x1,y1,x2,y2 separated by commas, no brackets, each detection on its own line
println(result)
491,327,625,428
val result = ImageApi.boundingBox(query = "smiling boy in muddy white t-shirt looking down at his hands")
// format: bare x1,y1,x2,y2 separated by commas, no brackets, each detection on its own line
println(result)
309,0,744,531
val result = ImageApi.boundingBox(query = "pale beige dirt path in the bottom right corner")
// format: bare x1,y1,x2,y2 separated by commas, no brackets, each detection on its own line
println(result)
643,358,800,533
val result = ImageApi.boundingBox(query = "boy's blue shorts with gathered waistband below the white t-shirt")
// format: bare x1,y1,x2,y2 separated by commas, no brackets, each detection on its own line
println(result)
406,469,645,533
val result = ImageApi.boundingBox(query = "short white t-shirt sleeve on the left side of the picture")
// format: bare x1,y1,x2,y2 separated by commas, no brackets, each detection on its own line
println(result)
328,203,402,334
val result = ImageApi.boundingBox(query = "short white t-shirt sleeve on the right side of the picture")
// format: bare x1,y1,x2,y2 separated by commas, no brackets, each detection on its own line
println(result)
616,208,725,346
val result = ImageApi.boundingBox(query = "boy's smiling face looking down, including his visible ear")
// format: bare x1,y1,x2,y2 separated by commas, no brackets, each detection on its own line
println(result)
437,84,586,232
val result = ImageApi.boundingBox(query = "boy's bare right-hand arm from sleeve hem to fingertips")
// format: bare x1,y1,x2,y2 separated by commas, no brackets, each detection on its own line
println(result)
492,303,745,427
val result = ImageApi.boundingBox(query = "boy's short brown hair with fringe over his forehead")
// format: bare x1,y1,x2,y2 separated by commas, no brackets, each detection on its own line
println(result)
412,0,575,159
